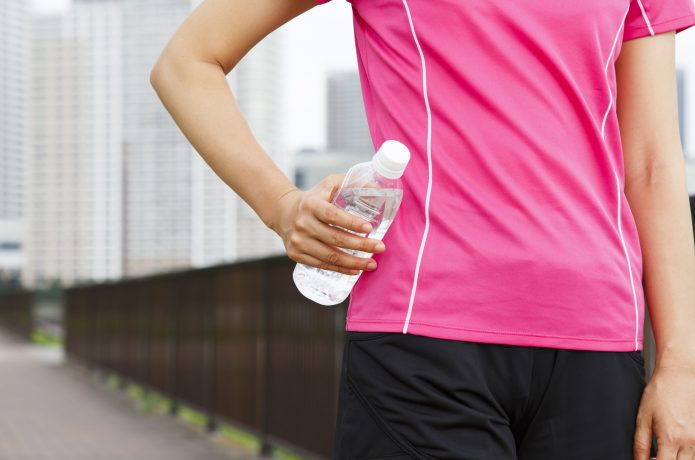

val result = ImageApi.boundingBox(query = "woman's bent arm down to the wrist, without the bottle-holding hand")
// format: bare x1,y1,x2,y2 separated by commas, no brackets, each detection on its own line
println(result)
150,0,316,229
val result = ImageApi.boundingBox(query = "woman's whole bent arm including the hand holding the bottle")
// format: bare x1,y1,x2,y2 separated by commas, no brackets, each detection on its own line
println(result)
150,0,383,274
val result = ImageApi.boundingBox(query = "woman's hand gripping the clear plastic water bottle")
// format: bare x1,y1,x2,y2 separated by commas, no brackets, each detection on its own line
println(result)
269,173,385,275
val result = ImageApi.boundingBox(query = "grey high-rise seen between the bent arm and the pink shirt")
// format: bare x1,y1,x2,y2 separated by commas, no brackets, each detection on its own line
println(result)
326,70,375,153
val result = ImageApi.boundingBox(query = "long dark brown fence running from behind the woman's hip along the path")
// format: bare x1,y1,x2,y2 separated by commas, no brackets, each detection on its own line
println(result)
64,255,349,458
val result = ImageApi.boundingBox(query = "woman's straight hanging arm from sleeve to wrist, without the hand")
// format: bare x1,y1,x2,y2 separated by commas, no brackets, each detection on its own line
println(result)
616,32,695,366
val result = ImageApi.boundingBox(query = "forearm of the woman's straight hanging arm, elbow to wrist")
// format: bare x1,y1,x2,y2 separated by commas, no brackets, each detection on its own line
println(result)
625,161,695,366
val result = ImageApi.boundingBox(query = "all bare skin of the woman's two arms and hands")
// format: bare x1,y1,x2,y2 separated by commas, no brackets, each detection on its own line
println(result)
150,0,695,460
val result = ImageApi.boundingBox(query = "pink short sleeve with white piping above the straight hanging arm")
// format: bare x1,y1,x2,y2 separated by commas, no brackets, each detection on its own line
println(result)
623,0,695,40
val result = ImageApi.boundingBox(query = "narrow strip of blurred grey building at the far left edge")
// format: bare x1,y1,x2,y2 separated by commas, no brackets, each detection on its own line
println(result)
0,0,28,284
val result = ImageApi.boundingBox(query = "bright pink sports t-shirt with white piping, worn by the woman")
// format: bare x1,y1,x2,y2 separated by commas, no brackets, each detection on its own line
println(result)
317,0,695,351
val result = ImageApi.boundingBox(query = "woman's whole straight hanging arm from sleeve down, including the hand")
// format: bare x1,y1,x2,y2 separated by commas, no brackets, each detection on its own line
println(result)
616,32,695,460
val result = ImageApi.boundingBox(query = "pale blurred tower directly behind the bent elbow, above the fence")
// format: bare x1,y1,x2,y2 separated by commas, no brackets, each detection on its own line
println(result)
118,0,193,276
